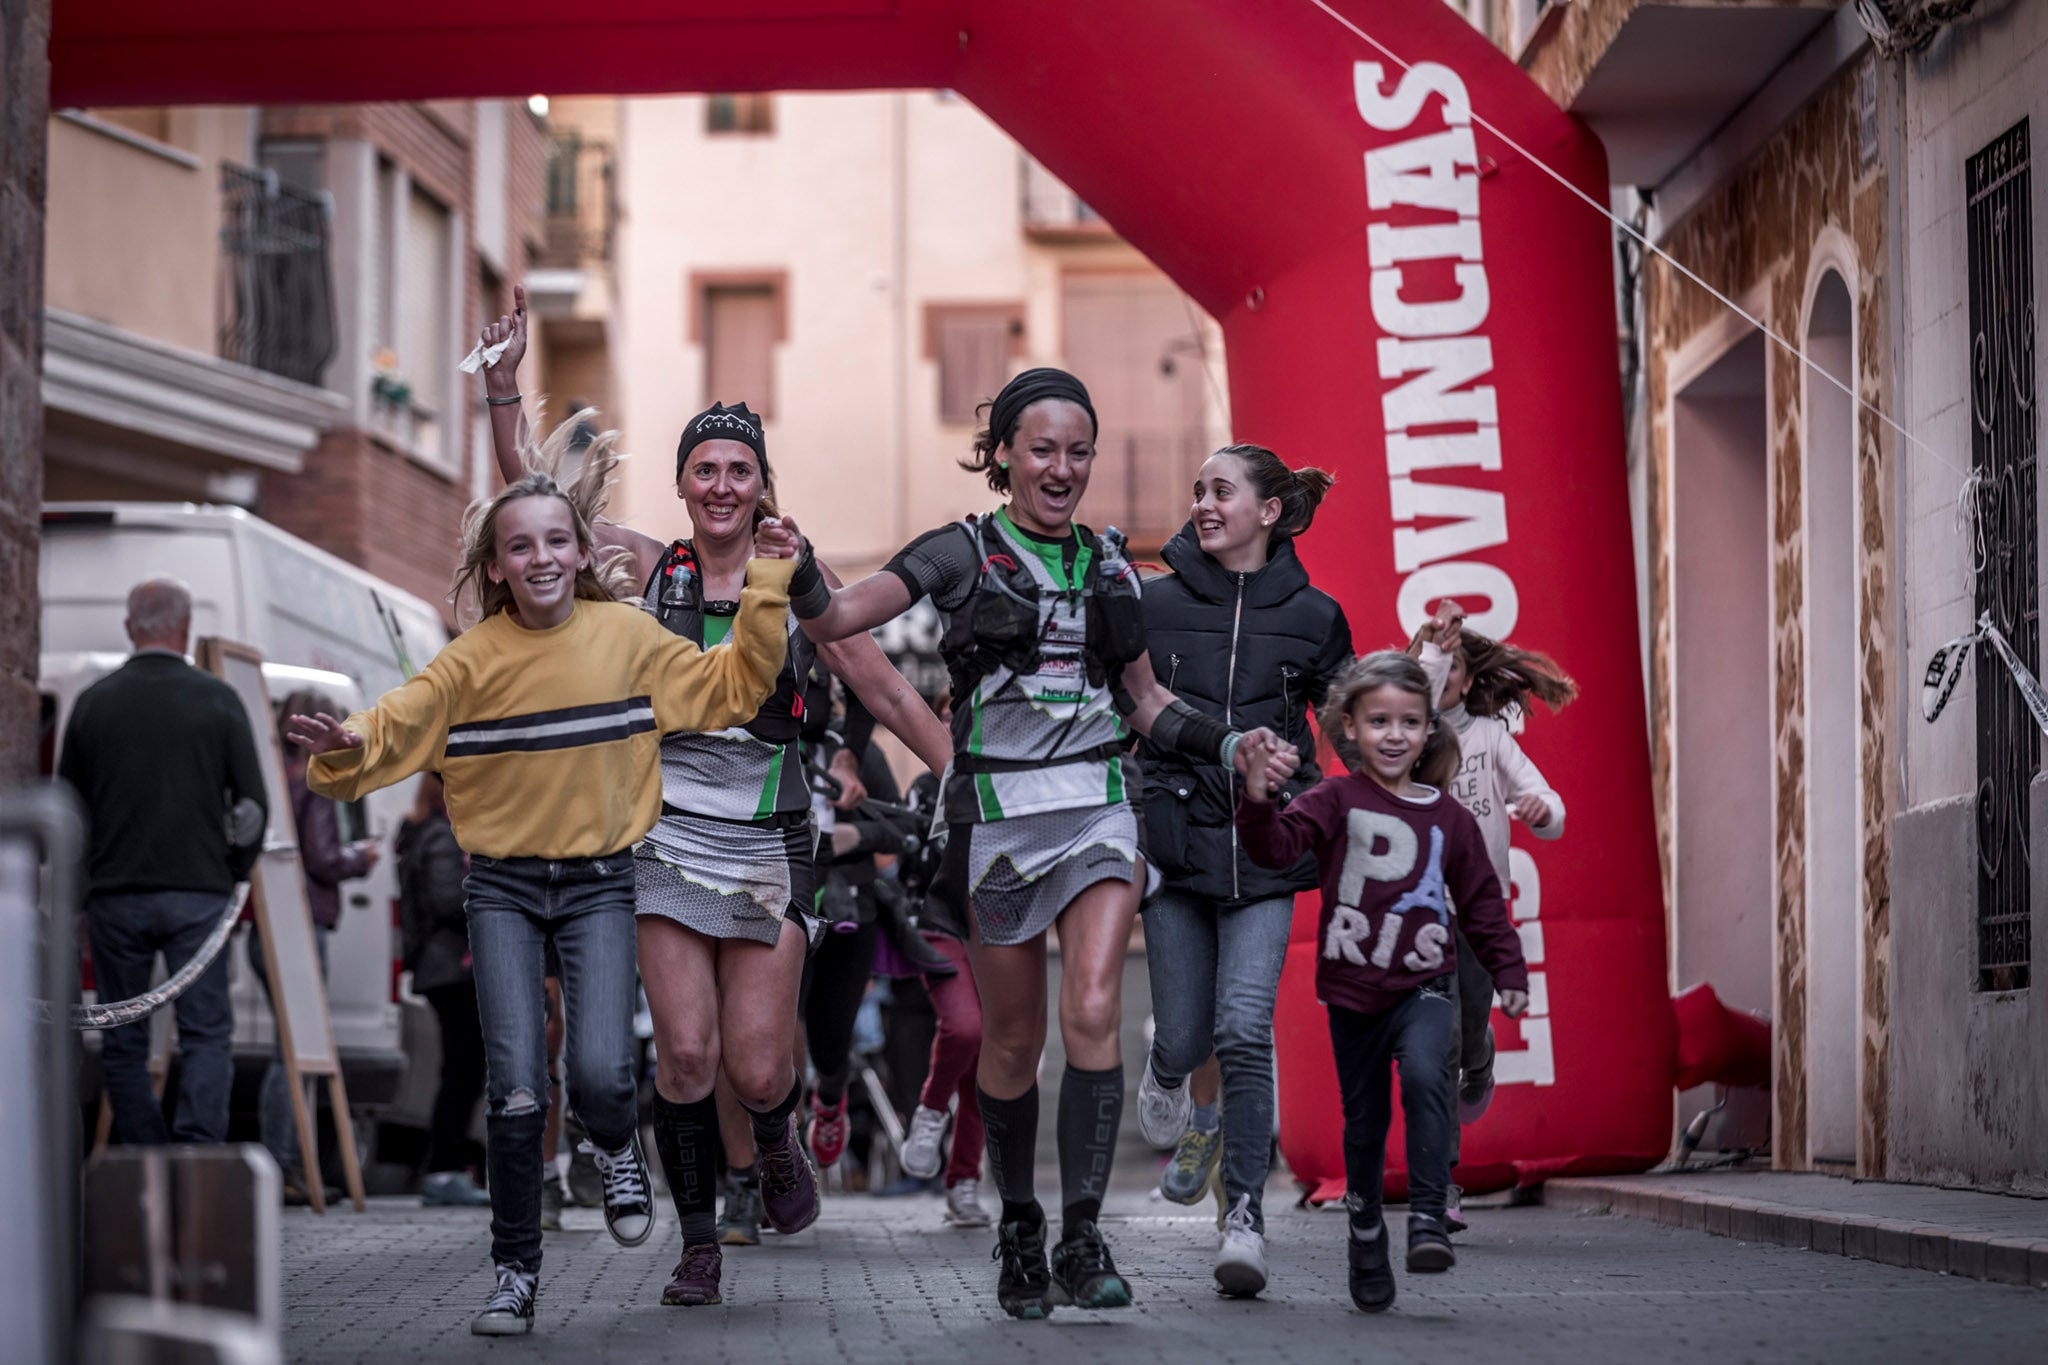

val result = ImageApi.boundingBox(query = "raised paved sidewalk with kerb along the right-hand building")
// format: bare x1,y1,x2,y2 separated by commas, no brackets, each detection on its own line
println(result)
1544,1171,2048,1289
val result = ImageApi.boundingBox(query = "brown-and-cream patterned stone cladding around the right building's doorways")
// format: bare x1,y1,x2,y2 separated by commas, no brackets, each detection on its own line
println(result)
1642,63,1894,1175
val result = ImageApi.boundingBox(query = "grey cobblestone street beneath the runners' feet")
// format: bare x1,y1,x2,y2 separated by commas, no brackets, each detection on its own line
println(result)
285,1187,2048,1365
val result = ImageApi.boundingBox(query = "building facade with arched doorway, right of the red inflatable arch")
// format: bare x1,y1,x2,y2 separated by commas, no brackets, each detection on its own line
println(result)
1515,0,2048,1189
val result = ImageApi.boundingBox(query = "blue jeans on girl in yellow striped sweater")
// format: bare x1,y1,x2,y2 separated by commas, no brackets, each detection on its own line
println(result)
463,851,639,1271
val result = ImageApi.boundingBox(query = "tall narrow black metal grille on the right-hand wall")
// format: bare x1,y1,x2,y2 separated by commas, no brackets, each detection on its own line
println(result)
1964,119,2040,990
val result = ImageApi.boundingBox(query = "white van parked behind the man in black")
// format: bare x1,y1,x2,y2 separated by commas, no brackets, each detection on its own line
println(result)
41,503,449,1111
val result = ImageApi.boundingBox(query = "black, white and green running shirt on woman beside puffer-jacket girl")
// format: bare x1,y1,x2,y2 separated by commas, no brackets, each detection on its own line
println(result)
887,512,1137,825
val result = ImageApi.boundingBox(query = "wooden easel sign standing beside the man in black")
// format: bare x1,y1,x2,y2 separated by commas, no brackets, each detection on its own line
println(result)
195,636,362,1214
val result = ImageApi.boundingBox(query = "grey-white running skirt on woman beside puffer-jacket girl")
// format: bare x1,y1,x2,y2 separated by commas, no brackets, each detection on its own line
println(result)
934,802,1139,948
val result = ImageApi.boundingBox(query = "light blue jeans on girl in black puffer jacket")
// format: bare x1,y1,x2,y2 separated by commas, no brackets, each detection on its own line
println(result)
1145,890,1294,1232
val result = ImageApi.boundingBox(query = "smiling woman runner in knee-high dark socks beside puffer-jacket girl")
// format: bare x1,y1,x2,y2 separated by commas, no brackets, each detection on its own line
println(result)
764,368,1276,1318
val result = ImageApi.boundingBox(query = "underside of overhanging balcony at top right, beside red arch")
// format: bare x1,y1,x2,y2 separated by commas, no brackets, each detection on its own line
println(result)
1509,0,1864,201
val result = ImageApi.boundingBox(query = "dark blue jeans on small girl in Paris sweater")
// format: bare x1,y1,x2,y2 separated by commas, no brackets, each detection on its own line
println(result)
1329,978,1458,1226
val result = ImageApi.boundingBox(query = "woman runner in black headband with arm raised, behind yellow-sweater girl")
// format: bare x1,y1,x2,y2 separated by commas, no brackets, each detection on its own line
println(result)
483,289,952,1306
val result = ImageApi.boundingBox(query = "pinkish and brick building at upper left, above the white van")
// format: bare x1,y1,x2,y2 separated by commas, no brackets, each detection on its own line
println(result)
41,93,547,618
